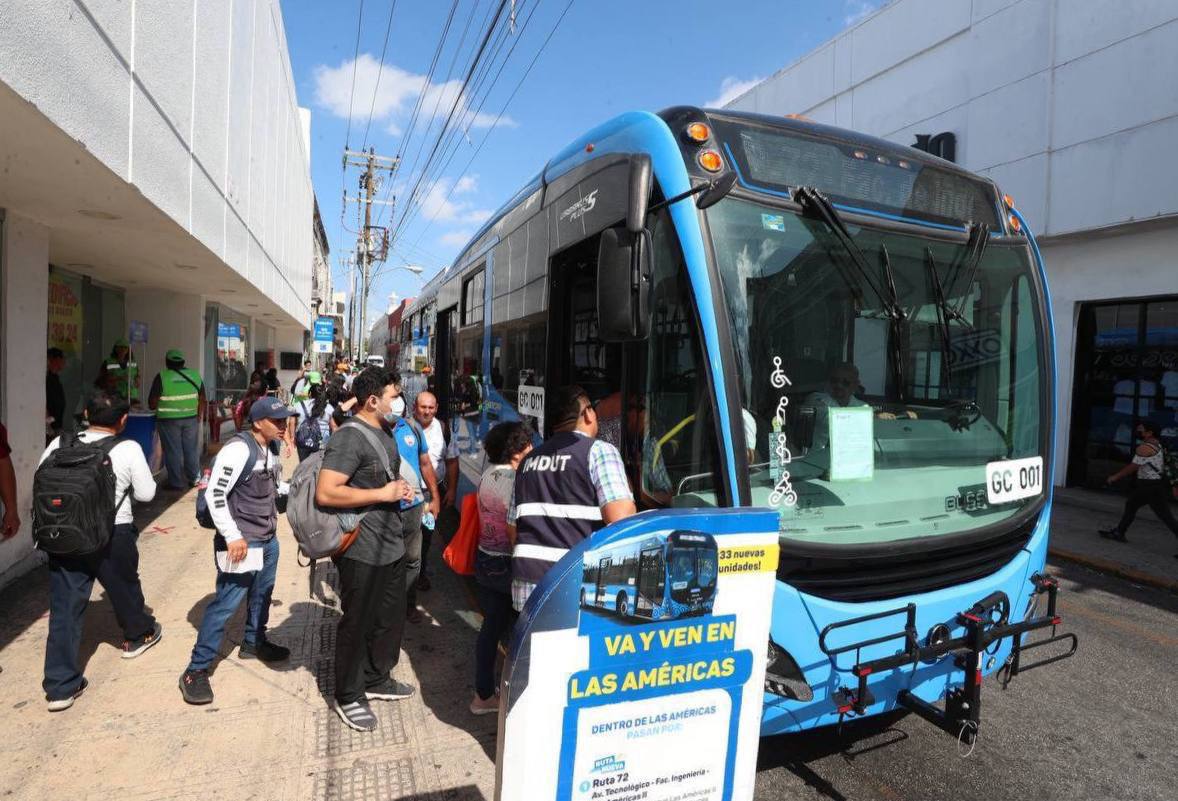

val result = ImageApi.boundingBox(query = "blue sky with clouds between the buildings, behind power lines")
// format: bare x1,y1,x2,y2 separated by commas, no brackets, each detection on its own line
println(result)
282,0,884,315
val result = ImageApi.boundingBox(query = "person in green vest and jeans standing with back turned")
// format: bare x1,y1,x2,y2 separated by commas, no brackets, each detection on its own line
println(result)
147,347,205,491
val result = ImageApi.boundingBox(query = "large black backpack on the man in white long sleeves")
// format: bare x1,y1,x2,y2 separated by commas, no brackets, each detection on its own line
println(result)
33,432,131,556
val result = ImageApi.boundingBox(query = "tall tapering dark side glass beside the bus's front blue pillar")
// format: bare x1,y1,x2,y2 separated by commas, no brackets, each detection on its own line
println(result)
628,212,720,507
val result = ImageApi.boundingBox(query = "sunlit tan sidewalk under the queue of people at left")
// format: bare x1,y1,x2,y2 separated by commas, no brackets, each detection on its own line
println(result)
0,468,497,801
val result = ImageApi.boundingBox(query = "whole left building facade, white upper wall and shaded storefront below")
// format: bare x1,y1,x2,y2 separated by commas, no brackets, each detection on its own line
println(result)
0,0,313,583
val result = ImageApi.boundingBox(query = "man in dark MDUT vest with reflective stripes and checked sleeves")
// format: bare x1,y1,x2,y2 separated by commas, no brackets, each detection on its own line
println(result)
508,386,637,610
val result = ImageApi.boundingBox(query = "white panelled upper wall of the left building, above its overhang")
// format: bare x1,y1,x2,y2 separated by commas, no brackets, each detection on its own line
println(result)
0,0,312,325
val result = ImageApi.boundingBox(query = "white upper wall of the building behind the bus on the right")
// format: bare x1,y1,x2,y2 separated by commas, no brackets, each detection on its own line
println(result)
729,0,1178,237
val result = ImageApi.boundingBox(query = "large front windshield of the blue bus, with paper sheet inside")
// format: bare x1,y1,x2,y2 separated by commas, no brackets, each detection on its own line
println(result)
707,197,1046,544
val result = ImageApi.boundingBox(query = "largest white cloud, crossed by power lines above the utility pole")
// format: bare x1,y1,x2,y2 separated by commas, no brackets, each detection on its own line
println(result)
313,53,517,135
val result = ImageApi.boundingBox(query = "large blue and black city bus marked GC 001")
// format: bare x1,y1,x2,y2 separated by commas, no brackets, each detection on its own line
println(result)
409,106,1077,742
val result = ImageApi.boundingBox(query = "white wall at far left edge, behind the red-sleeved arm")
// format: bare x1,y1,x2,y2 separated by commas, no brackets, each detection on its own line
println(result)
0,212,49,585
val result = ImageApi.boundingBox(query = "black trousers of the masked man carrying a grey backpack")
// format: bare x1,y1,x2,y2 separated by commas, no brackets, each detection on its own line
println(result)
336,556,408,703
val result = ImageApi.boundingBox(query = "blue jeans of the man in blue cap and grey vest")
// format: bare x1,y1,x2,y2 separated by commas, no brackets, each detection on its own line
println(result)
188,535,278,670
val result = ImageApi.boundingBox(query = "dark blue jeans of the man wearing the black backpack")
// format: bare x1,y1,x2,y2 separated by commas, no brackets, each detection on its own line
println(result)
41,523,155,701
